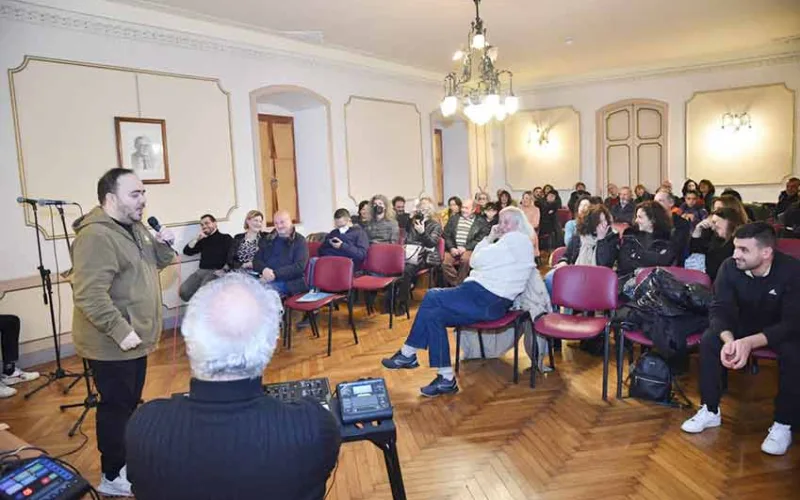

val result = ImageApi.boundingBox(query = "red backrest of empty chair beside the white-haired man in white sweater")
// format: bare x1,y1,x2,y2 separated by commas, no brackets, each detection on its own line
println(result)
552,266,619,311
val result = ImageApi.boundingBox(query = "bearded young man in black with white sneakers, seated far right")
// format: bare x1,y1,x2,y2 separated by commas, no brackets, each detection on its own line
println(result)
681,222,800,455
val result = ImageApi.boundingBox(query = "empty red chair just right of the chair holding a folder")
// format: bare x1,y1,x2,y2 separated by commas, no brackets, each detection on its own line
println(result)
353,243,407,328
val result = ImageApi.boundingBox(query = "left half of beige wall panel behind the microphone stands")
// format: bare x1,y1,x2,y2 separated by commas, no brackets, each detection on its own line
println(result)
12,60,136,235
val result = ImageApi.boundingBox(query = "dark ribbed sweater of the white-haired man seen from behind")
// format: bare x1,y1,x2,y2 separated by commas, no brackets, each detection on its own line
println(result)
125,377,341,500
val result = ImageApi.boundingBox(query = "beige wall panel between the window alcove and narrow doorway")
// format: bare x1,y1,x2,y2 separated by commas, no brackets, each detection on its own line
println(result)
345,96,425,203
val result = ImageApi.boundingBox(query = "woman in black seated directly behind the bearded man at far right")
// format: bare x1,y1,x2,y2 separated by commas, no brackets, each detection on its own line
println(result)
689,208,746,281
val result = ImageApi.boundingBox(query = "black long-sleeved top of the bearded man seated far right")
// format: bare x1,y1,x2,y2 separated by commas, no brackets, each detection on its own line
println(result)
709,252,800,347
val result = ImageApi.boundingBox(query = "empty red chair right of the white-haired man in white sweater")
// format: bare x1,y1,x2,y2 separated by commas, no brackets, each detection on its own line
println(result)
531,266,619,399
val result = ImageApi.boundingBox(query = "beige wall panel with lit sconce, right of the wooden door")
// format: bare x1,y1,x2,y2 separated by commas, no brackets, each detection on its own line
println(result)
686,84,795,185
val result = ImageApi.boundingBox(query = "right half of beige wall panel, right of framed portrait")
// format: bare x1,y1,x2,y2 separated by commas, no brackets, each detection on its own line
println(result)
138,74,236,224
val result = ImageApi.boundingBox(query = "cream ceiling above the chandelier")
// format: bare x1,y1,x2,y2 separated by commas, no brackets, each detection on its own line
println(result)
115,0,800,83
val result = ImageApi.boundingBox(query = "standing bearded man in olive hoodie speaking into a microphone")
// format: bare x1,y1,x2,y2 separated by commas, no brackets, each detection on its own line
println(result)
72,168,175,496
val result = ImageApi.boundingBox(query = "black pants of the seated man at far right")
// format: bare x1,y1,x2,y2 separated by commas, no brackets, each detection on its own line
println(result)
700,330,800,426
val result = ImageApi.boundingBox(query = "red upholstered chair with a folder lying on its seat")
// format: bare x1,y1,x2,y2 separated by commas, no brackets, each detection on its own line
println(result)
284,257,358,356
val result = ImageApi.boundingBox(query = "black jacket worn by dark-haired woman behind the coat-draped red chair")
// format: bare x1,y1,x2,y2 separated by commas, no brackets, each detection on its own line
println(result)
617,228,675,279
